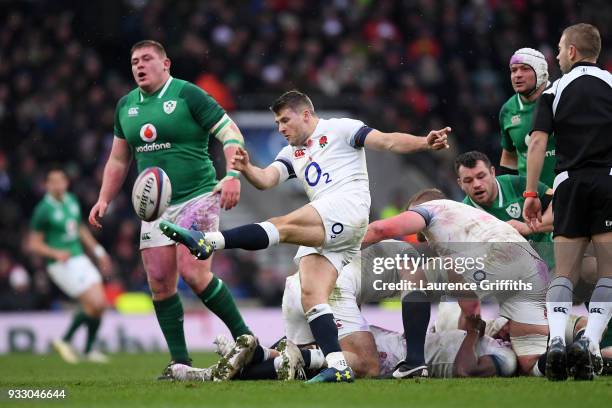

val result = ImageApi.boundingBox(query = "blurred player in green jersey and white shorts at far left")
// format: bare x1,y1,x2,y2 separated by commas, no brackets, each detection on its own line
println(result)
29,168,111,364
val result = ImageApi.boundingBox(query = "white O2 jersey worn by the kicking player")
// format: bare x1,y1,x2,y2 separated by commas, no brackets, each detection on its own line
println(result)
272,118,372,201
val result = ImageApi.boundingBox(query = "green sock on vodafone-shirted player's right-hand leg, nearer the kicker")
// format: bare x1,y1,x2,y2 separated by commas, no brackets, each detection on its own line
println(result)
198,276,253,338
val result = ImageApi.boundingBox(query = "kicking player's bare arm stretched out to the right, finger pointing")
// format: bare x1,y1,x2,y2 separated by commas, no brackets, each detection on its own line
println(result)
364,127,451,153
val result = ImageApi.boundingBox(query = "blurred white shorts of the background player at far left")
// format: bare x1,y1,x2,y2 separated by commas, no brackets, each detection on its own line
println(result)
47,255,102,298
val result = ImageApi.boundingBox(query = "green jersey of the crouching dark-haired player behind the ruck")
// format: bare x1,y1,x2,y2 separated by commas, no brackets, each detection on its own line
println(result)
463,174,555,268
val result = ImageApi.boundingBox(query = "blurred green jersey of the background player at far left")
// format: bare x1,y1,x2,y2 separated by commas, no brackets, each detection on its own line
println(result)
30,193,83,262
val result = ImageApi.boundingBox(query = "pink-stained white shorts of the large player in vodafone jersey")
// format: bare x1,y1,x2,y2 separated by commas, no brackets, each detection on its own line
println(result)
140,193,221,249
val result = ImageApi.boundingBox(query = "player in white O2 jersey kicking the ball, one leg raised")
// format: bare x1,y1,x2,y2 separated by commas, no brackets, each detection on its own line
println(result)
161,91,451,382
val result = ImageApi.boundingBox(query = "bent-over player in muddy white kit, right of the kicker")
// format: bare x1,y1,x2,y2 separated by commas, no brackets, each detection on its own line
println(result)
363,189,548,375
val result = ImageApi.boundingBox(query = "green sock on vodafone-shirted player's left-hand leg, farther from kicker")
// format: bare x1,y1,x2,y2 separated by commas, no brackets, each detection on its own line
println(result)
153,293,189,361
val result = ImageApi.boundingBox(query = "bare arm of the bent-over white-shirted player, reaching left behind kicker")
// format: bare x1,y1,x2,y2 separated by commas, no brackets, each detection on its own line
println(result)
361,210,425,248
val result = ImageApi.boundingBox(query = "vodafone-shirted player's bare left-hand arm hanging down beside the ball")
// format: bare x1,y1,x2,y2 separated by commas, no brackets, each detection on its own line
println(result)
89,137,132,228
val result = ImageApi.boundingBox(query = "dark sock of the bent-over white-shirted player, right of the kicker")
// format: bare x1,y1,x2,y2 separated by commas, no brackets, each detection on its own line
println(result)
402,292,431,366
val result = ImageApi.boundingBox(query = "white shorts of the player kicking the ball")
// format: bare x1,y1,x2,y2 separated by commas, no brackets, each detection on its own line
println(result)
294,192,370,273
